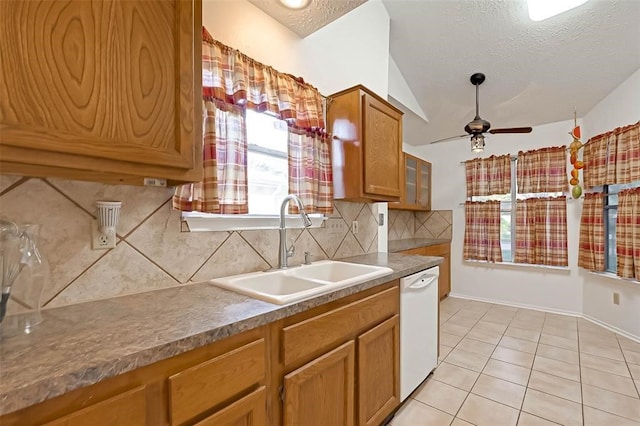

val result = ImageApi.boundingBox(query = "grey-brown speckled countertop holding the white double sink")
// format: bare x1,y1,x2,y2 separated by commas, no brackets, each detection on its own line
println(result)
0,253,442,414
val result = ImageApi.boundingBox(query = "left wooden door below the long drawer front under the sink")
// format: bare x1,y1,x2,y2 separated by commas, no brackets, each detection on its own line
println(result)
283,340,355,426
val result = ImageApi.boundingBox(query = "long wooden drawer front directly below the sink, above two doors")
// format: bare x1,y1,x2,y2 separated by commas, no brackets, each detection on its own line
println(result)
282,287,400,365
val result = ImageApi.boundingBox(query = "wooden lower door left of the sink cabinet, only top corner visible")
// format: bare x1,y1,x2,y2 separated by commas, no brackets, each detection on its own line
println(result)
195,386,267,426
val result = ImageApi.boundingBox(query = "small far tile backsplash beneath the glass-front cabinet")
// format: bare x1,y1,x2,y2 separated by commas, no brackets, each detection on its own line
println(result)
389,210,453,241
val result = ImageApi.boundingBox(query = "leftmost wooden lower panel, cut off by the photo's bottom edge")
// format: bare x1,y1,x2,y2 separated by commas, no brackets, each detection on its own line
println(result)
47,386,147,426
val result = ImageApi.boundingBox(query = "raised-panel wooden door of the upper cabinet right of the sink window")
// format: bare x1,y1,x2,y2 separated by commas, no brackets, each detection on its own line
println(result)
362,93,402,198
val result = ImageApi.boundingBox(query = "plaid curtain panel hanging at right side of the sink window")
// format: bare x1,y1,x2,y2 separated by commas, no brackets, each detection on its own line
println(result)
288,127,333,214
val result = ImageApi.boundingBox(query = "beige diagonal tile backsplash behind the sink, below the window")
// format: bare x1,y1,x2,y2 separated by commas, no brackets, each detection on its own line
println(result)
0,175,378,314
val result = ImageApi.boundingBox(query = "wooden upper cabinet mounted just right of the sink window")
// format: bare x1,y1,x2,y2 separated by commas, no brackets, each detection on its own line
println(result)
327,86,404,202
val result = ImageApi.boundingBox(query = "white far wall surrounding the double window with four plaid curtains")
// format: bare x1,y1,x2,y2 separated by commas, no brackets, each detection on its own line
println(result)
413,120,582,313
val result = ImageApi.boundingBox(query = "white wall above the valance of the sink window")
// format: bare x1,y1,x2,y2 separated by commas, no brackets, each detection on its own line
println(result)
202,0,390,98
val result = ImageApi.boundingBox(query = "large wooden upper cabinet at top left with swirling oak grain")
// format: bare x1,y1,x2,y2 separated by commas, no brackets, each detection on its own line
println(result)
0,0,202,184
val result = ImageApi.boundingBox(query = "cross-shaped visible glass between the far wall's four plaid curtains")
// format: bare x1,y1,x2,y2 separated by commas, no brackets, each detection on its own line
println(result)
470,157,564,262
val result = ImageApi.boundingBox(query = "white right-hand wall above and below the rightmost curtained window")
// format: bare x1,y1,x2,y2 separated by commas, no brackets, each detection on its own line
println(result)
582,70,640,336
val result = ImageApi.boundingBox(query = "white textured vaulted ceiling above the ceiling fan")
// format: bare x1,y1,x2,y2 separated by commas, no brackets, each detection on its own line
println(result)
250,0,640,145
